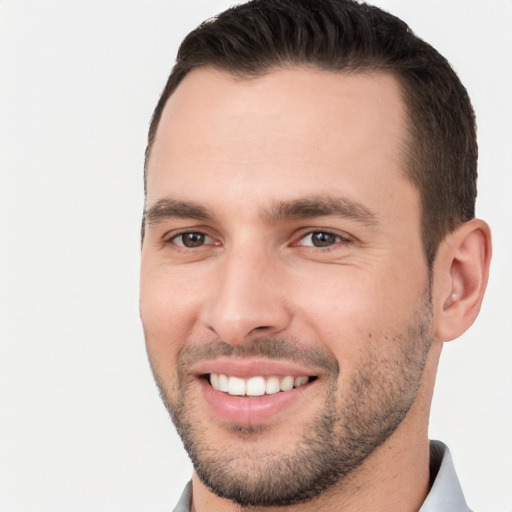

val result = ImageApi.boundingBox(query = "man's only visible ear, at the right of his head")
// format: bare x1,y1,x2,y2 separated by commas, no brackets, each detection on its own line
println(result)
433,219,492,341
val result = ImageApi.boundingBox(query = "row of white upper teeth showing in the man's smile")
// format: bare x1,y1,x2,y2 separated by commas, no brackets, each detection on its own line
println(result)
210,373,309,396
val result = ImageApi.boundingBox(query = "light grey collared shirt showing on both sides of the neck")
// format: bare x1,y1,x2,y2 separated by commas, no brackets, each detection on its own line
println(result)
173,441,471,512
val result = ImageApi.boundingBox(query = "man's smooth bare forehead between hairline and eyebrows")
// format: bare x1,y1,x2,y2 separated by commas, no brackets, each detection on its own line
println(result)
147,67,411,220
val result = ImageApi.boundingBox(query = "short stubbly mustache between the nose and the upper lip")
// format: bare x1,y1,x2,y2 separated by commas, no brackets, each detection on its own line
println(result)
178,338,340,374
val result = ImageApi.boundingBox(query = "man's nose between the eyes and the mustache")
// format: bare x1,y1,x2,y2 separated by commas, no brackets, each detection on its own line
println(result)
202,242,292,344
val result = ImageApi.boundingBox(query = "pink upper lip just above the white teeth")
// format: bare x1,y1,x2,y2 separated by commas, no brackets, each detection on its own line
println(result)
192,358,318,379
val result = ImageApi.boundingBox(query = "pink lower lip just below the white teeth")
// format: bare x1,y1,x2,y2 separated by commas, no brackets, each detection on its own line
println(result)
201,379,313,425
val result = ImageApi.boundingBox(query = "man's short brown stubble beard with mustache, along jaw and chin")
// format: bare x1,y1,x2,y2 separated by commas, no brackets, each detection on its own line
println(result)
153,290,433,507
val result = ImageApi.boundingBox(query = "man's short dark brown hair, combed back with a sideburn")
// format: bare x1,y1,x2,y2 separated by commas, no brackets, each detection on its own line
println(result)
146,0,478,268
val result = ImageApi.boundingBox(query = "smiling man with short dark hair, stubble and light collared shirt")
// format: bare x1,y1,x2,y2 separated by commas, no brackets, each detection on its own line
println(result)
140,0,491,512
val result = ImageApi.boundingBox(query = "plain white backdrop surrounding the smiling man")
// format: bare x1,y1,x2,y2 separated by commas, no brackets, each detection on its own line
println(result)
0,0,512,512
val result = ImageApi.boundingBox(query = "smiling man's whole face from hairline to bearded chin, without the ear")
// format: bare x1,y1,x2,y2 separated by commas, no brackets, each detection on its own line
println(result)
140,68,432,505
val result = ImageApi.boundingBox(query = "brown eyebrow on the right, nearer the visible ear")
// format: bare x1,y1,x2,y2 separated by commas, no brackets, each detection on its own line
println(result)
263,195,380,227
